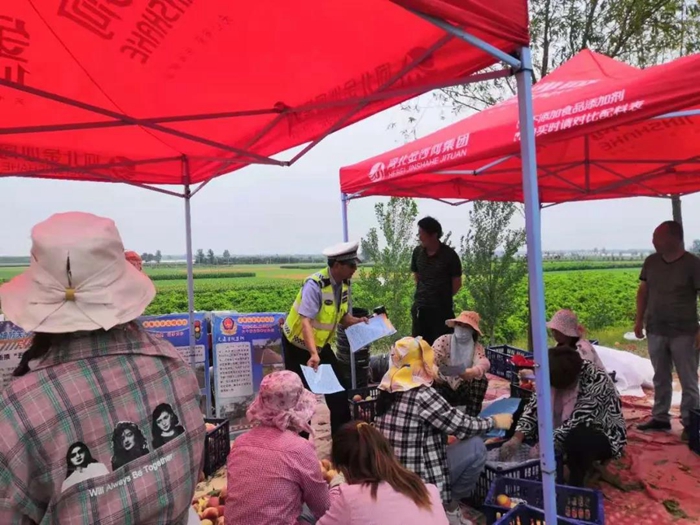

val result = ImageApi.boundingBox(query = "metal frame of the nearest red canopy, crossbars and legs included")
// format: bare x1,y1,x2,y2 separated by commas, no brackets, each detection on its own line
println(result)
0,4,556,523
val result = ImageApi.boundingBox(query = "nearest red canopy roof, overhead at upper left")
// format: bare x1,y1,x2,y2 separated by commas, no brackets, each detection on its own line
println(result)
0,0,528,188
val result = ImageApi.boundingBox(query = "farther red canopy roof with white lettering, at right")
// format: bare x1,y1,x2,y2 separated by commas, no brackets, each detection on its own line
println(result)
340,51,700,202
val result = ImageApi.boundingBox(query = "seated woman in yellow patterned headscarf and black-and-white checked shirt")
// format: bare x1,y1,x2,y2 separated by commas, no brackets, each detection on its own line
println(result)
375,337,513,524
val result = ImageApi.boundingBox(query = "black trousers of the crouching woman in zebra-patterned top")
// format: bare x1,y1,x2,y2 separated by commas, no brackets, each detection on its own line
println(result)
564,425,612,487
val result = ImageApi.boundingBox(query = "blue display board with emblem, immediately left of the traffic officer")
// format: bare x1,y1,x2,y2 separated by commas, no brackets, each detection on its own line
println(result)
211,312,285,429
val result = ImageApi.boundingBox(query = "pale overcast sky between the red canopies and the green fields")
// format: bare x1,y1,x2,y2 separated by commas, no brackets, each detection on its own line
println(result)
0,99,700,255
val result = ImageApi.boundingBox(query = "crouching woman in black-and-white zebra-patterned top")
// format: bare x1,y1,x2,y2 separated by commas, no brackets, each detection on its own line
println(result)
500,347,627,487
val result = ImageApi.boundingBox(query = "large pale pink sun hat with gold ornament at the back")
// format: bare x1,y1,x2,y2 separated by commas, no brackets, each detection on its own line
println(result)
0,212,156,333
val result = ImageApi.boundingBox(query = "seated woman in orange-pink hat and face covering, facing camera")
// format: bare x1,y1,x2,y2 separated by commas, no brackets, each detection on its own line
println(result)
433,312,491,417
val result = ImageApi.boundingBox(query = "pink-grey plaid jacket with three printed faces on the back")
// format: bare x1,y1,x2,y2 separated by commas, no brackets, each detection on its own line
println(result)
0,324,205,525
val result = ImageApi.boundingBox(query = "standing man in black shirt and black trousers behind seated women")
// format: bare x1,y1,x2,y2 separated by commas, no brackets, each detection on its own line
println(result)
411,217,462,345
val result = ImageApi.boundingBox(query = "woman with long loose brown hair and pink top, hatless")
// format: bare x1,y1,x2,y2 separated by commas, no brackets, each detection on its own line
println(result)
317,421,448,525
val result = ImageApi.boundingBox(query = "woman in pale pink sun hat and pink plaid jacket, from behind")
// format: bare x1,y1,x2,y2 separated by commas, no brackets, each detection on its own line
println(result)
0,212,205,524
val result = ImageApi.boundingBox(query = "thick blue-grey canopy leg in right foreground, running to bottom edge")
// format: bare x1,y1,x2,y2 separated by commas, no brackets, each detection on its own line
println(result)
516,47,557,523
